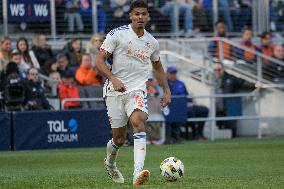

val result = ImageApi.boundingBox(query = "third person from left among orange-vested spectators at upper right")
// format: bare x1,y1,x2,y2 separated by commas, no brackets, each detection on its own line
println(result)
259,32,273,64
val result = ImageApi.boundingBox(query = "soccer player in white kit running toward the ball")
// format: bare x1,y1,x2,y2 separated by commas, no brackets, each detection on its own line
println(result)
96,0,171,185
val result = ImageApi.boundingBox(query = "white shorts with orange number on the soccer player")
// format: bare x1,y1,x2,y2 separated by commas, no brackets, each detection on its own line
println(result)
106,90,148,128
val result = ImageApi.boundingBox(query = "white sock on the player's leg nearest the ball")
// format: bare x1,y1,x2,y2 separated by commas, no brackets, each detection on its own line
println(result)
133,132,146,176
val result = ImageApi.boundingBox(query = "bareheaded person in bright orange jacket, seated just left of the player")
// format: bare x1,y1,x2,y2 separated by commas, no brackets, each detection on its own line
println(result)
76,54,103,86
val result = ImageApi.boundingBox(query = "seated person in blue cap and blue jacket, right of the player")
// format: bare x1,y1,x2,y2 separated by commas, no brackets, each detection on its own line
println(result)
167,66,209,140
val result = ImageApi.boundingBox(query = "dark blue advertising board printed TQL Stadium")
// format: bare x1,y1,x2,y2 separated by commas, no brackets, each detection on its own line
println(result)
13,110,110,150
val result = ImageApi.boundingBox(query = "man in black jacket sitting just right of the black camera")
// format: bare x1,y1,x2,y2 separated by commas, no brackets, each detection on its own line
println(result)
25,67,52,110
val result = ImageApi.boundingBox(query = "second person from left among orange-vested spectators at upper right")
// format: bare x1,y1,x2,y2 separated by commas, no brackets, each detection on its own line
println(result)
235,27,257,64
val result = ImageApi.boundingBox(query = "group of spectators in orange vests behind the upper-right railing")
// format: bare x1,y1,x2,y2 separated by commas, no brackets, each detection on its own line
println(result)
208,21,284,82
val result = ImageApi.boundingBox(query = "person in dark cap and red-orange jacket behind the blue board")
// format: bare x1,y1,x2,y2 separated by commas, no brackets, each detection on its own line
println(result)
58,70,81,109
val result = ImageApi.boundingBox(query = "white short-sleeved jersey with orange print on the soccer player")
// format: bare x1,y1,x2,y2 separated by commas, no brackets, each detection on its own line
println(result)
101,24,160,96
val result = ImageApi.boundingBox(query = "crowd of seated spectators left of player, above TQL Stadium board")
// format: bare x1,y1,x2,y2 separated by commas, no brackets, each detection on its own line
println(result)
0,33,104,111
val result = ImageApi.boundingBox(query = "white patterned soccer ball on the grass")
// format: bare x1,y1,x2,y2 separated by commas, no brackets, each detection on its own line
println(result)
160,157,184,181
